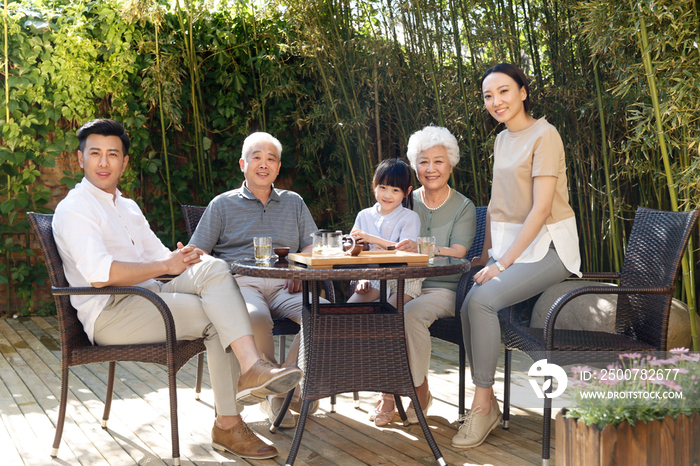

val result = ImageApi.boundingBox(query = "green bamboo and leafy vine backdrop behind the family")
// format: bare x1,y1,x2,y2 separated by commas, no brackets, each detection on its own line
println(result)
0,0,700,313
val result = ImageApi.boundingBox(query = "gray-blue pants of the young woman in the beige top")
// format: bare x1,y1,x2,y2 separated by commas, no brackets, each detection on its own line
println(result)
461,245,571,388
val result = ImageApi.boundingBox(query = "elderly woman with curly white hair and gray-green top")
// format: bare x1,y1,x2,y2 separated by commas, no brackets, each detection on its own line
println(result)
370,126,476,426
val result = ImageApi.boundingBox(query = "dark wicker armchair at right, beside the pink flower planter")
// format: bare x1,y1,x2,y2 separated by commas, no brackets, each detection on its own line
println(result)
501,207,698,465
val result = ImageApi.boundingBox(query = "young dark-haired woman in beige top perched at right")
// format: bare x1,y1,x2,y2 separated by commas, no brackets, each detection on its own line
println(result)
452,63,581,449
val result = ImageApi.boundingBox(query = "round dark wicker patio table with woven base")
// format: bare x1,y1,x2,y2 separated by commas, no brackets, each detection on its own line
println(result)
231,256,470,466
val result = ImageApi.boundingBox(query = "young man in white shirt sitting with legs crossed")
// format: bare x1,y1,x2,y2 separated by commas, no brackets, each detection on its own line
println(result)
53,119,302,459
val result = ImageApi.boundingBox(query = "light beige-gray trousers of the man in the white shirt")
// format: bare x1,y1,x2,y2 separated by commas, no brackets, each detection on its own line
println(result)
95,255,253,416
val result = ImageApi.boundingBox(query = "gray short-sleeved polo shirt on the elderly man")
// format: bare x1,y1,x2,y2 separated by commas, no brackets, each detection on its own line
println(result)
190,185,317,263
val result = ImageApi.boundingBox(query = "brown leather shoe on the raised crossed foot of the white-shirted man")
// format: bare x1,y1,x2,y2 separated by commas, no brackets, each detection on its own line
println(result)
236,359,304,406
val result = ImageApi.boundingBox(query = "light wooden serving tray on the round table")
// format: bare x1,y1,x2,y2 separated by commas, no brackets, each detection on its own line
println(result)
287,251,428,269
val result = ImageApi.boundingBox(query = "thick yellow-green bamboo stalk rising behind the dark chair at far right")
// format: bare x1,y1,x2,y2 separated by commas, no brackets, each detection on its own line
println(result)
638,8,700,351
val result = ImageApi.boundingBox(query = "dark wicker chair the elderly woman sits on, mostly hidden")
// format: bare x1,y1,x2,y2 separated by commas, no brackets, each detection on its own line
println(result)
429,207,487,416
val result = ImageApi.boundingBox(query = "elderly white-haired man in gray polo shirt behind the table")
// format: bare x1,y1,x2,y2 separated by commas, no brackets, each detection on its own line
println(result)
190,132,318,428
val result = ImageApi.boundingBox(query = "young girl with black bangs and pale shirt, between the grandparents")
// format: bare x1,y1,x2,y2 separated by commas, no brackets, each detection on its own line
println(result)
348,158,422,312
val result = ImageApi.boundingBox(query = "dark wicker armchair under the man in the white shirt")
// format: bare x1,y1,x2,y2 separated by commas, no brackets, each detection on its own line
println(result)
27,212,205,465
